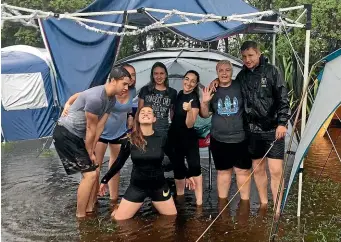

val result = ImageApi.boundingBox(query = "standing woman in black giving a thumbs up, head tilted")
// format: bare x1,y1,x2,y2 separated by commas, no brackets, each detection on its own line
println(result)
169,70,202,205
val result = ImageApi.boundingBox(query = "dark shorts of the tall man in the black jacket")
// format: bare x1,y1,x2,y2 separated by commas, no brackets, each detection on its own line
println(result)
248,131,285,160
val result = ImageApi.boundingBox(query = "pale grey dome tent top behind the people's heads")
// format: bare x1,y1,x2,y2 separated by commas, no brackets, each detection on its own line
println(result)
116,48,243,91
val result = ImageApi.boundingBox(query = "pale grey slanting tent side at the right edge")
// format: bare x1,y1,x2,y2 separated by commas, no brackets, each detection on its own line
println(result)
284,49,341,206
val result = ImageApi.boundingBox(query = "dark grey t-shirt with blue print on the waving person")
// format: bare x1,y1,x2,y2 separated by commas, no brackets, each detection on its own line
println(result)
209,81,245,143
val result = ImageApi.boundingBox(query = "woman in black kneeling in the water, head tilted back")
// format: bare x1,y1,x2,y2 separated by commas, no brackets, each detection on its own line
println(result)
100,107,177,220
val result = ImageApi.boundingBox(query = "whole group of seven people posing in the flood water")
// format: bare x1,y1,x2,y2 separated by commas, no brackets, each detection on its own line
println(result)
53,41,289,220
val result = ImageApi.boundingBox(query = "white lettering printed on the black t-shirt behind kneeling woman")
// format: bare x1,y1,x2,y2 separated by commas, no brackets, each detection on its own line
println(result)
145,94,171,118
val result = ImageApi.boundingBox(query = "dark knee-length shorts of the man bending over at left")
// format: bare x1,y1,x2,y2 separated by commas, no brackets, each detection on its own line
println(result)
53,124,98,175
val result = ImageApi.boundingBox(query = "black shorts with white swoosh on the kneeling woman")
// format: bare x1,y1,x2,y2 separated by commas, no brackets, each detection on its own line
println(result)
123,183,172,203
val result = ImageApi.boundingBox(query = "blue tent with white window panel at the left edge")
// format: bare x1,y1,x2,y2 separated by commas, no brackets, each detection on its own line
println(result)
1,46,59,141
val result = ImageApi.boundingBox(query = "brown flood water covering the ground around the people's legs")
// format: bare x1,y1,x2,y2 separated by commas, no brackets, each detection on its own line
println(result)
1,128,341,242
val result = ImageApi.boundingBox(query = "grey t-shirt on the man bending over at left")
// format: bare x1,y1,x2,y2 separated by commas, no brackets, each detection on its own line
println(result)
58,85,116,139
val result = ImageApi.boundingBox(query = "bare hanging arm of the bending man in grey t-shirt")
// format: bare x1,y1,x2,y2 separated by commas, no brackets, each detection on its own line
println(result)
85,112,99,156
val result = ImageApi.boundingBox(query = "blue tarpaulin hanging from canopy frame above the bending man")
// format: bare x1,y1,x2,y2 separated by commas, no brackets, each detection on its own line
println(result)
41,1,125,105
